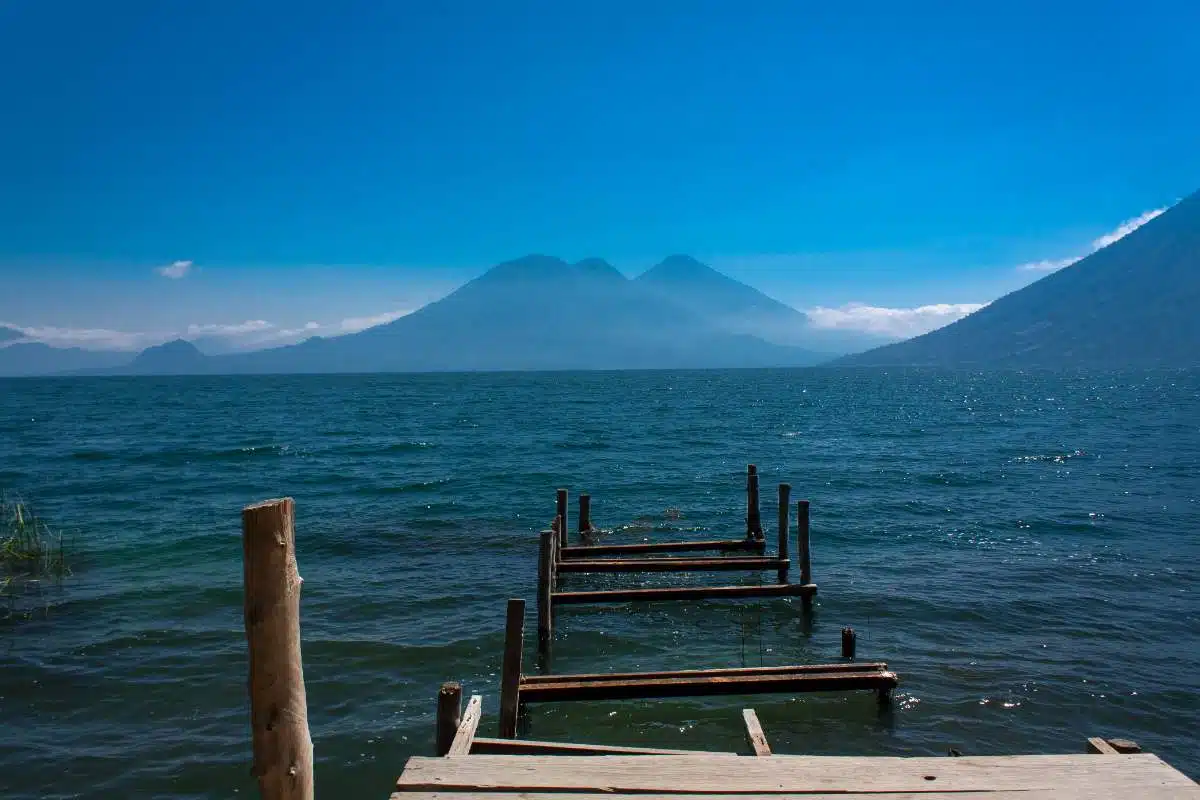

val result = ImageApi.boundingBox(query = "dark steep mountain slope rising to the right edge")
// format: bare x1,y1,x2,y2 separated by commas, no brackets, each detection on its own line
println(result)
835,193,1200,367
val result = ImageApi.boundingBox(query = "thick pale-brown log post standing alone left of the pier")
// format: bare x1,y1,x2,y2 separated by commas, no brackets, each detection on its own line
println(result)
241,498,313,800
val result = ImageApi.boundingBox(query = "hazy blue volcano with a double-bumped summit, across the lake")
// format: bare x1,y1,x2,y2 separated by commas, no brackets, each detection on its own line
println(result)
204,255,821,372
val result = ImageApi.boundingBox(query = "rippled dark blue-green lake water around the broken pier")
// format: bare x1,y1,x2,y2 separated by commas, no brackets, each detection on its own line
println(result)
0,369,1200,798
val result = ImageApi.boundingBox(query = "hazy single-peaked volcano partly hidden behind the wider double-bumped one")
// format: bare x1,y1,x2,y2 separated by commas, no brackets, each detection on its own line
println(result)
636,255,892,356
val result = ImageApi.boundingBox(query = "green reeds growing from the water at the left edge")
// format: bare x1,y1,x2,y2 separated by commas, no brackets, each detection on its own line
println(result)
0,495,71,616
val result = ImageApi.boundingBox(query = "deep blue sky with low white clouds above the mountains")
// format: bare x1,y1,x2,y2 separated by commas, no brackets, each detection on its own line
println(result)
0,0,1200,347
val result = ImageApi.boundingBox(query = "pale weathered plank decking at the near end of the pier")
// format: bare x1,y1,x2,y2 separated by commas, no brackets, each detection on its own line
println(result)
397,753,1200,800
